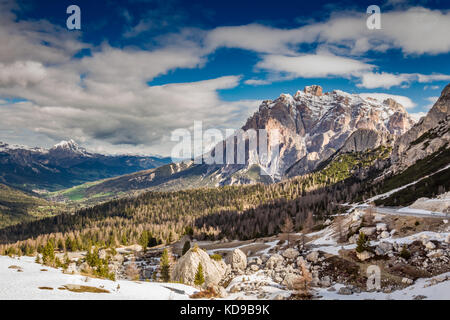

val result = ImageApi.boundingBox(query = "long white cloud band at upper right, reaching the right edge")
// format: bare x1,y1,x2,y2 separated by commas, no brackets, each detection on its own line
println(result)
205,7,450,54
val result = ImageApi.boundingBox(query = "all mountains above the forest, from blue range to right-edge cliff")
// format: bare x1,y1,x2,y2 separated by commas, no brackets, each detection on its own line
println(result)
0,85,450,231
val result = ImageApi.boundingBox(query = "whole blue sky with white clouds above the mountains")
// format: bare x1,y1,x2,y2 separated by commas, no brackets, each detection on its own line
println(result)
0,0,450,155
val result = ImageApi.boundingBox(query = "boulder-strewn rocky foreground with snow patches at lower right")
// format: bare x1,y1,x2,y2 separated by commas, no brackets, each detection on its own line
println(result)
17,202,450,299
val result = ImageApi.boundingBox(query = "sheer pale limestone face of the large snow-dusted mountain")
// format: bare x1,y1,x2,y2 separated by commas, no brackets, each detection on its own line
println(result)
239,86,413,176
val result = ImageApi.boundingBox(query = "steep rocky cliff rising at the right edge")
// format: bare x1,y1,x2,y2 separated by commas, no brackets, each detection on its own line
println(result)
392,84,450,172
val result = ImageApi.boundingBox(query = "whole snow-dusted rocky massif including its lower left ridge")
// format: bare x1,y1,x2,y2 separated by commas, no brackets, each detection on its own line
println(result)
199,85,414,185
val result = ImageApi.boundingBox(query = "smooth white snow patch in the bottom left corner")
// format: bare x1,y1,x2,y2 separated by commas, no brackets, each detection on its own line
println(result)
0,256,198,300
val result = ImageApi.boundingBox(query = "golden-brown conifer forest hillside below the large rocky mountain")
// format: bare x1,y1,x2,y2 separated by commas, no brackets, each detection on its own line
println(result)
0,148,398,251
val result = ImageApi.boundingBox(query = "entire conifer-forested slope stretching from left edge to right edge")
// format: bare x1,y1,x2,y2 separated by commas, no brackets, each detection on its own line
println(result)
0,141,449,252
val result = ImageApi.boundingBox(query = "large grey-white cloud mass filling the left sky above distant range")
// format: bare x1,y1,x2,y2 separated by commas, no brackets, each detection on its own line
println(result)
0,2,257,154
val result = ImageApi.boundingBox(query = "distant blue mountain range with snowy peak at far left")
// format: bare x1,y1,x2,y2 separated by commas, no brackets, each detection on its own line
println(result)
0,140,171,191
